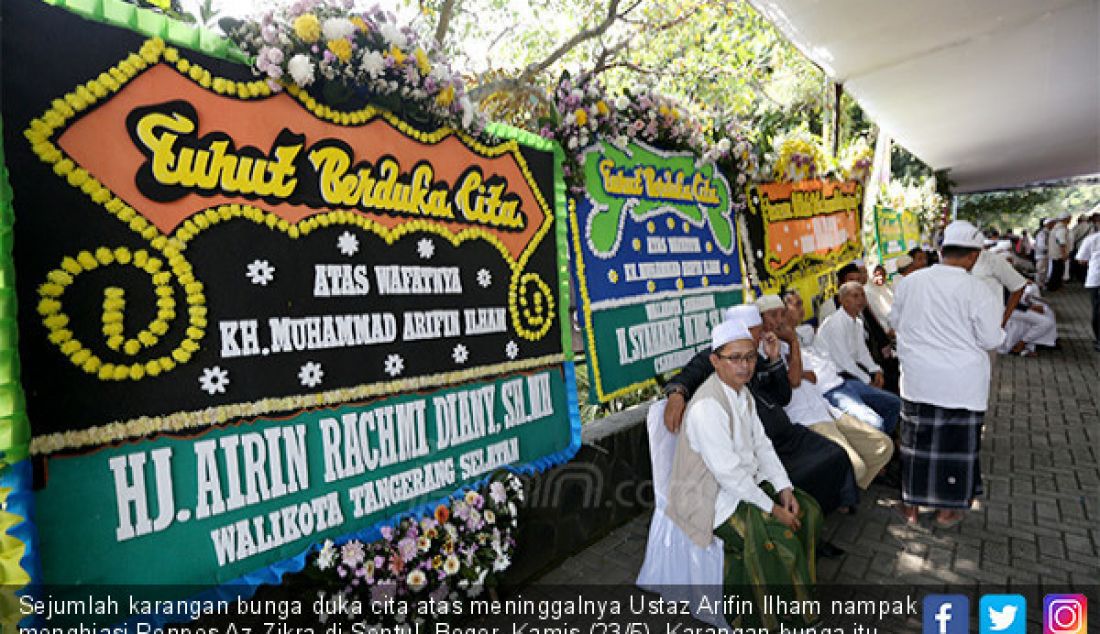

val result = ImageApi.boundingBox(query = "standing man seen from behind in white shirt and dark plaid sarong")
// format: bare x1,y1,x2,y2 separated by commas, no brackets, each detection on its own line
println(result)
890,220,1004,528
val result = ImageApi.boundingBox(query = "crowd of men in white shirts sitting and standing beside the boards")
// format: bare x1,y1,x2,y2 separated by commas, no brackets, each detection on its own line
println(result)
639,214,1100,626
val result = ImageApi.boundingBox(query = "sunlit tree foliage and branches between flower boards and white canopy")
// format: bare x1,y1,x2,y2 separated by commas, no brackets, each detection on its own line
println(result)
418,0,831,138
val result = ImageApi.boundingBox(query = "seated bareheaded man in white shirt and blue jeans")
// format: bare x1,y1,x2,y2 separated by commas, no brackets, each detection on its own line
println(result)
814,281,902,436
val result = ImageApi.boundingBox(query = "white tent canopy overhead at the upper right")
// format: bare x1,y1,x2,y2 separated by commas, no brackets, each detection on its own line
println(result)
751,0,1100,192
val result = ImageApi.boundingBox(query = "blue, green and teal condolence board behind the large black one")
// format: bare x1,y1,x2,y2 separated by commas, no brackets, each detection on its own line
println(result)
570,142,741,402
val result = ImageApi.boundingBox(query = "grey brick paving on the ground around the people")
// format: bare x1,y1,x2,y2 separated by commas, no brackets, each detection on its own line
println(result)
528,280,1100,601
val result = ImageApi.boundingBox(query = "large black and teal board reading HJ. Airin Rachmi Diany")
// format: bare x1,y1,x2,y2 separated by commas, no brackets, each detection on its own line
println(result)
2,0,580,592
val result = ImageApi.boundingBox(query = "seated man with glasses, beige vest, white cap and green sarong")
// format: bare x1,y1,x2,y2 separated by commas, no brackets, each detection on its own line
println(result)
666,321,822,631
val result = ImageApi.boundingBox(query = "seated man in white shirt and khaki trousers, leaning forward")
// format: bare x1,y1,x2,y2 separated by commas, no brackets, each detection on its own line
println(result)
757,295,893,490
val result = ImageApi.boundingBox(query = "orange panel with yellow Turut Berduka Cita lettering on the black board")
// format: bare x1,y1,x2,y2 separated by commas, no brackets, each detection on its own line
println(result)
57,63,551,261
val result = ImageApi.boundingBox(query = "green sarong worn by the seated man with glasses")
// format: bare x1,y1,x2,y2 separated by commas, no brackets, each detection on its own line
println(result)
714,482,822,631
